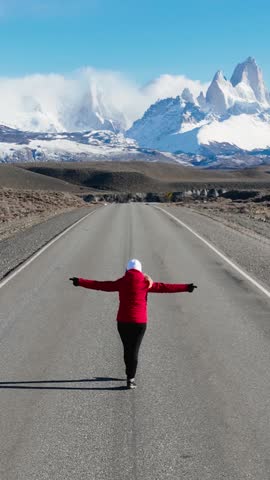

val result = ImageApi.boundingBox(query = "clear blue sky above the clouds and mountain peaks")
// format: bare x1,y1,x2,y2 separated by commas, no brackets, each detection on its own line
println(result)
0,0,270,88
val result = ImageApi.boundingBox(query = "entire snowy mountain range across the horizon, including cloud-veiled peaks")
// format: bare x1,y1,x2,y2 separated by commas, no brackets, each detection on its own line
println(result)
0,57,270,168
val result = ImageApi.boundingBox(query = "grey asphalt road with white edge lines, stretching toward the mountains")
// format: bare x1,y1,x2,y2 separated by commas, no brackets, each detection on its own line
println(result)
0,204,270,480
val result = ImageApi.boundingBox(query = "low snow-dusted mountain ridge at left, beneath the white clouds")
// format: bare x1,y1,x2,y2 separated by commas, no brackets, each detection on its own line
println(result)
0,125,189,165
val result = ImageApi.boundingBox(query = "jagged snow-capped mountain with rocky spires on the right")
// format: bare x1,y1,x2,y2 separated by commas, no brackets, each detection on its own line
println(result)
126,57,270,163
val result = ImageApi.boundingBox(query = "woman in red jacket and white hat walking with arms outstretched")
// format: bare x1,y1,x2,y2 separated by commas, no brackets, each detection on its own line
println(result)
70,259,197,389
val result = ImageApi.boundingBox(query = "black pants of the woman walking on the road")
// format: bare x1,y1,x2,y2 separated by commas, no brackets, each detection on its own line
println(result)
117,322,146,378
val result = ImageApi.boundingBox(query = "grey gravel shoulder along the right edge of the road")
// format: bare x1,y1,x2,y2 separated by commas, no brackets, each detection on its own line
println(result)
162,206,270,287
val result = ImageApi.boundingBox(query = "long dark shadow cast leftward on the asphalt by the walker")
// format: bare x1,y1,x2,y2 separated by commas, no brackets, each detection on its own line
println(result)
0,377,127,391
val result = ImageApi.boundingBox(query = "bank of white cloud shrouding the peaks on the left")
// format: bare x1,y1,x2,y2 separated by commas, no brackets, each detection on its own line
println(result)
0,67,209,131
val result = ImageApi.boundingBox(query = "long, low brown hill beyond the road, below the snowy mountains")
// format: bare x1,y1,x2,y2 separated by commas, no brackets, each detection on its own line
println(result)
20,162,270,192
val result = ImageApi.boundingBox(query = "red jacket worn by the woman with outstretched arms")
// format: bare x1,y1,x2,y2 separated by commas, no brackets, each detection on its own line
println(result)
79,270,188,323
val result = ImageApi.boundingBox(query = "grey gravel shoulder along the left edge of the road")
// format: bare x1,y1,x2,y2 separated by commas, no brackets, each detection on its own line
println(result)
0,206,98,279
